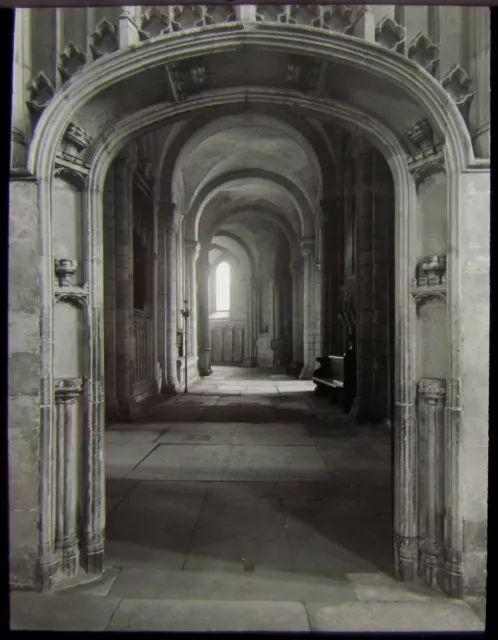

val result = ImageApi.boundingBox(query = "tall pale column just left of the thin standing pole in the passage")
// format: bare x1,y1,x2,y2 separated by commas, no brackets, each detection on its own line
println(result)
166,219,178,393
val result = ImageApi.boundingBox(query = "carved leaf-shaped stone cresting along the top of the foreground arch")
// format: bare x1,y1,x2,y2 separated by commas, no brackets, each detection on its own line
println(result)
21,4,474,138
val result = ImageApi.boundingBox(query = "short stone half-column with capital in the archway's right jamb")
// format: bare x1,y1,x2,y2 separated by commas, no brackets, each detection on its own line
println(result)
418,378,446,586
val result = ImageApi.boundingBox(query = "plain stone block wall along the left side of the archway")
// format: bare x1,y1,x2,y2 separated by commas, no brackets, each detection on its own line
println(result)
8,179,40,588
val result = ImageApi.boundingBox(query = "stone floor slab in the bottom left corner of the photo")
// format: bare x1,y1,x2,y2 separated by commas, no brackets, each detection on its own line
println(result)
10,591,120,631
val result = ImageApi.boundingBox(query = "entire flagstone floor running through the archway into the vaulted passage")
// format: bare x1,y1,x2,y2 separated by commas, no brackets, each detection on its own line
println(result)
11,367,484,631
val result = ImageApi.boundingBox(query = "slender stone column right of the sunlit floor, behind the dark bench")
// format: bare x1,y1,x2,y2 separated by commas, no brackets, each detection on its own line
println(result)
301,238,315,377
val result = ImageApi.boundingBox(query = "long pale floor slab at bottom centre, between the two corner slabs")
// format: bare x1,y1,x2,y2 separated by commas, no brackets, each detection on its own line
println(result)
109,600,309,631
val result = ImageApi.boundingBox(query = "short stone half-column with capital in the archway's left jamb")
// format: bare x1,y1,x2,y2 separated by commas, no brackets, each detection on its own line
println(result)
55,378,83,575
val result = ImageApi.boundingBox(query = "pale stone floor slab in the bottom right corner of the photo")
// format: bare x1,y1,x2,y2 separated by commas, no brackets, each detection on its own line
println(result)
306,600,484,632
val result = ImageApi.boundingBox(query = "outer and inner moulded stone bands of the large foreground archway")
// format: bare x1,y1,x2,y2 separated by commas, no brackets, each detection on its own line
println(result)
25,21,488,595
